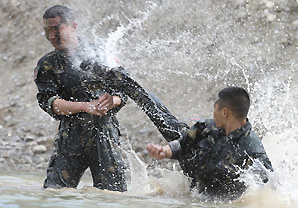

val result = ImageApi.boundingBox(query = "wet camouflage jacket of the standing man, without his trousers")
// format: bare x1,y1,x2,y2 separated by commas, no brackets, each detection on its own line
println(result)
35,42,127,120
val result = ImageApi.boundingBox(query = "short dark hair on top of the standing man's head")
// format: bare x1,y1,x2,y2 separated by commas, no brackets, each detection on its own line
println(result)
43,5,75,24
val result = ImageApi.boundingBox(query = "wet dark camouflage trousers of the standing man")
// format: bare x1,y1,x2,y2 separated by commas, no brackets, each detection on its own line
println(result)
44,115,127,192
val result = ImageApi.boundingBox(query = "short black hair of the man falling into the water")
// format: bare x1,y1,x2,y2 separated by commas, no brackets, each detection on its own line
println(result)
216,87,250,118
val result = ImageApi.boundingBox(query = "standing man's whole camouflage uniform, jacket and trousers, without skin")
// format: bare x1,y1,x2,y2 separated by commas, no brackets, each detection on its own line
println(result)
35,41,127,191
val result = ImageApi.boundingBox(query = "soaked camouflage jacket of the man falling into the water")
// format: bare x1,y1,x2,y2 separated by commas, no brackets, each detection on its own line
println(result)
169,119,272,199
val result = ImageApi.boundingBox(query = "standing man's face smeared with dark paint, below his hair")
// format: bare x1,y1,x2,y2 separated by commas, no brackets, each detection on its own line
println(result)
43,17,76,50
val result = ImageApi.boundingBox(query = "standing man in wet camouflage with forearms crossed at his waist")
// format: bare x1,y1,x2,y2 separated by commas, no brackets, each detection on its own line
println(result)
35,5,127,191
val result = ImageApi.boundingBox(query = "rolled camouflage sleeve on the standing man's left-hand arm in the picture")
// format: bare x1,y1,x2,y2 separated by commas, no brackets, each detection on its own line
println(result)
34,60,63,119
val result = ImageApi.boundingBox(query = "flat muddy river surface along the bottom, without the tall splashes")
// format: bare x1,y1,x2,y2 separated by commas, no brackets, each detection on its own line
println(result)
0,169,298,208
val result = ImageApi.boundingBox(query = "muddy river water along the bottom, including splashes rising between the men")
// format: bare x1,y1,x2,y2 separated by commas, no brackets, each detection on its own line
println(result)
0,150,298,208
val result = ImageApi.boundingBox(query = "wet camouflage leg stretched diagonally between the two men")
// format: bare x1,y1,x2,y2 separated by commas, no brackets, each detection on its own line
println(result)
81,61,188,141
